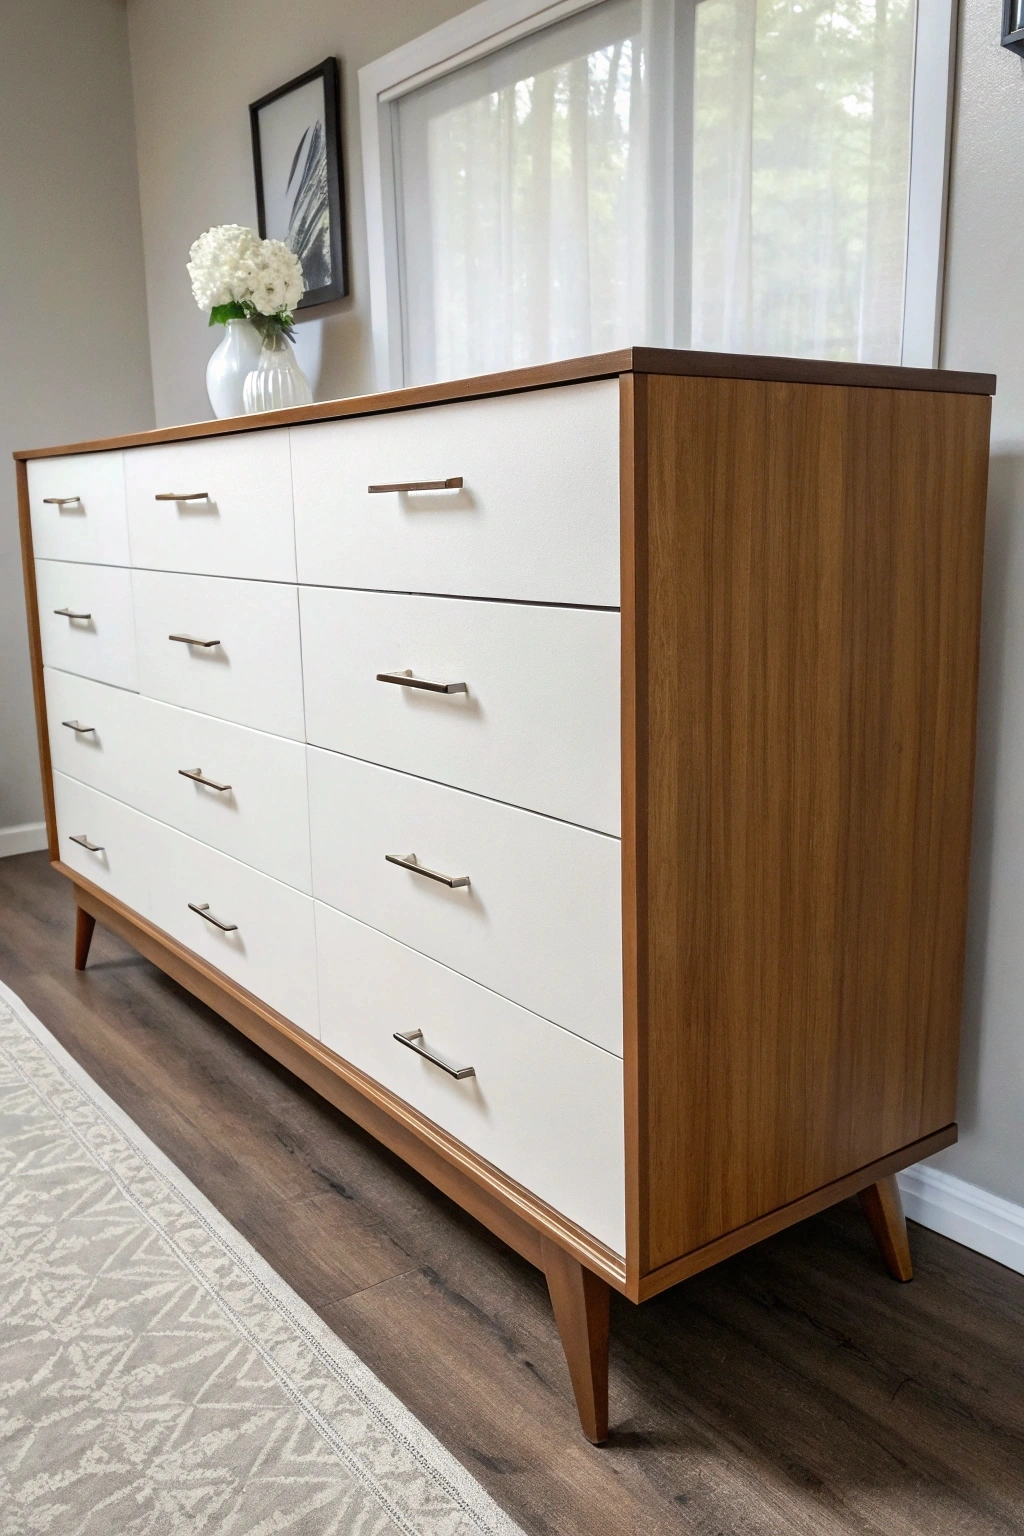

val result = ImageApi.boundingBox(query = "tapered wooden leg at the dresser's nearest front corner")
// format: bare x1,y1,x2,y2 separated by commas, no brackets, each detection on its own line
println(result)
540,1238,609,1445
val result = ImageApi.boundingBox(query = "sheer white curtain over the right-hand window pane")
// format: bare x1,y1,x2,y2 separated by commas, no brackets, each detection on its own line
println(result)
692,0,915,362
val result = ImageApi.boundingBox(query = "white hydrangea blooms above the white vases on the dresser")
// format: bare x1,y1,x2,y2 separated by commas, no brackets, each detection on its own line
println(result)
189,224,306,339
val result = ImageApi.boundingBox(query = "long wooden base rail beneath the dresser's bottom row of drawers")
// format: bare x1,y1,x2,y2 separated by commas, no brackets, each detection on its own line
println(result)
66,862,625,1290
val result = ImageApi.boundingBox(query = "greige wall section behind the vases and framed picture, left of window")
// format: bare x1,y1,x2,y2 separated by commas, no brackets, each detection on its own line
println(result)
127,0,482,425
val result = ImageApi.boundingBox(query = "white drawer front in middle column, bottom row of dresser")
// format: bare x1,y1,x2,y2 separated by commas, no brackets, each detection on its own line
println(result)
149,822,318,1035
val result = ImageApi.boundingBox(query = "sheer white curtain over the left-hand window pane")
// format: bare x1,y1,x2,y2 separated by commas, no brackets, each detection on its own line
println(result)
399,0,645,382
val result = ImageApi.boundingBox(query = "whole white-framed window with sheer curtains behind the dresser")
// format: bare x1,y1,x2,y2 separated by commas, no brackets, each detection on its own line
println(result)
361,0,952,386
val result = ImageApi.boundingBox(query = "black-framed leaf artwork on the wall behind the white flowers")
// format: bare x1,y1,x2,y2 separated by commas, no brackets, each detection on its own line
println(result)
249,58,348,309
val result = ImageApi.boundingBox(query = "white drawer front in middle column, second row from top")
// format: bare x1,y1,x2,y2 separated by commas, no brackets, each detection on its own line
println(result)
132,570,304,740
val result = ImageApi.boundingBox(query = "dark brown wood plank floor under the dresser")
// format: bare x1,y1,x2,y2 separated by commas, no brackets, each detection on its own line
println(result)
0,854,1024,1536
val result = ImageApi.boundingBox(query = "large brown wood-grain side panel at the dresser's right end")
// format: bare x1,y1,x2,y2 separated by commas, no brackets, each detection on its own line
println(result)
640,376,989,1269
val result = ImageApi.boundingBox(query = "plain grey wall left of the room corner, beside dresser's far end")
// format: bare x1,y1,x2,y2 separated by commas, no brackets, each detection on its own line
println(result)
0,0,154,846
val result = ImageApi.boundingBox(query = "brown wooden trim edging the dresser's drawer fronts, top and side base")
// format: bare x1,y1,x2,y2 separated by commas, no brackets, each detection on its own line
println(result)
14,349,995,1303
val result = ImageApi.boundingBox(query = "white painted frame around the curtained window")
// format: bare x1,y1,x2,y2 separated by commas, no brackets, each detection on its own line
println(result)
359,0,958,390
